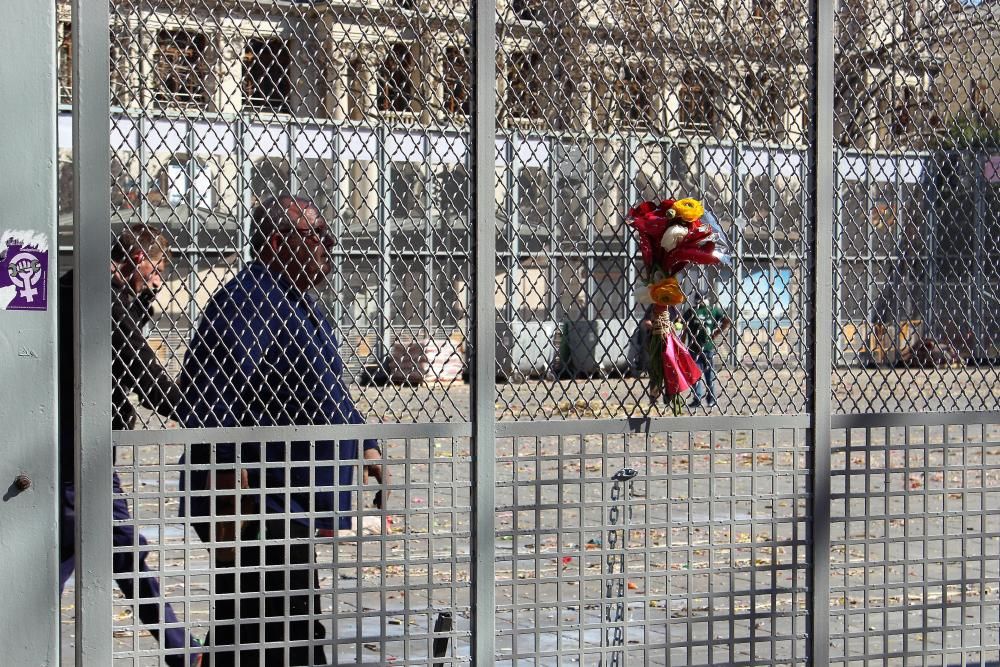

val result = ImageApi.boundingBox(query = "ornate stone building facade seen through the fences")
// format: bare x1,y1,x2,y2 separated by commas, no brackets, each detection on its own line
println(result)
59,0,1000,376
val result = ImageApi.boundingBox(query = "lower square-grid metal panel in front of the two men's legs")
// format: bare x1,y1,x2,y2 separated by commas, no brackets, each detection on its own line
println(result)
82,431,472,667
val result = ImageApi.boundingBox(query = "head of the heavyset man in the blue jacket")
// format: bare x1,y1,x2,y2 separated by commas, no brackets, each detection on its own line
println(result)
250,195,336,291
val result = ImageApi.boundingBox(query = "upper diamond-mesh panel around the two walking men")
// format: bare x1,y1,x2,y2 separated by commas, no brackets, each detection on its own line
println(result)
79,0,472,426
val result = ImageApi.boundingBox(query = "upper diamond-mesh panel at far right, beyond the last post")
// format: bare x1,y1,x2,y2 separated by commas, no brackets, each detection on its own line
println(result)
834,0,1000,412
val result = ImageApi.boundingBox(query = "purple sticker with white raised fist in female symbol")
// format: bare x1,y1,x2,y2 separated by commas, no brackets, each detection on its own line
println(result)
0,229,49,310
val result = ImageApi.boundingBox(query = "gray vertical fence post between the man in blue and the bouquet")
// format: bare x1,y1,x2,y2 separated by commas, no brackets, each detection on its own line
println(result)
472,0,497,667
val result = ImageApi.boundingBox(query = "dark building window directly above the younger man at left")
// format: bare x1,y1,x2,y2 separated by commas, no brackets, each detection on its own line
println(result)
153,30,208,104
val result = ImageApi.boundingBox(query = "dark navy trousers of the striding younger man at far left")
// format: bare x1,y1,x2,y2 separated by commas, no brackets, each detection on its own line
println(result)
59,474,199,667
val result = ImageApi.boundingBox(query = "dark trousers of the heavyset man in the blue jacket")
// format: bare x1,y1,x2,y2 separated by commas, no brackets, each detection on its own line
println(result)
195,520,327,667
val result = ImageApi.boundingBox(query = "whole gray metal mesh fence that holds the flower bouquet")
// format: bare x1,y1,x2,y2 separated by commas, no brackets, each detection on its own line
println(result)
57,0,1000,665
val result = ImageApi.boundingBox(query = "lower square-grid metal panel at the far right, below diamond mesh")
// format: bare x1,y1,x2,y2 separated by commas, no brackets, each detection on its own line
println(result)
830,423,1000,666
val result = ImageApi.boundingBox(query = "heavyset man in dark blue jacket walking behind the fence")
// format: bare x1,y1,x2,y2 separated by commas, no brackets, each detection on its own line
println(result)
180,195,388,667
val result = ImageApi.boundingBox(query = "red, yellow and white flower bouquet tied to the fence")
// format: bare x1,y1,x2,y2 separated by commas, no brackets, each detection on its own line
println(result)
628,199,727,415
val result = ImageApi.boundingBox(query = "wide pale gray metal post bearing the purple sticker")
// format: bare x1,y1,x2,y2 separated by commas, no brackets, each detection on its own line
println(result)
0,2,59,665
